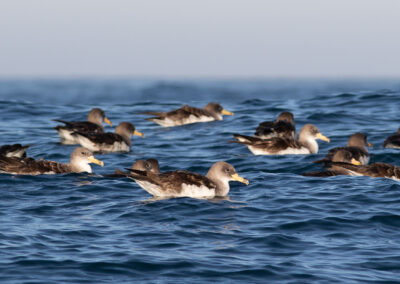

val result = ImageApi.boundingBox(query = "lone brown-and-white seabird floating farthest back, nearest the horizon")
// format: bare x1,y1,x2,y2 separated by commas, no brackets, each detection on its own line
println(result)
145,103,233,127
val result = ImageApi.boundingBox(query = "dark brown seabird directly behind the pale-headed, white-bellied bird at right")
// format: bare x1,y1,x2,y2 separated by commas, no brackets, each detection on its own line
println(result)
254,111,296,139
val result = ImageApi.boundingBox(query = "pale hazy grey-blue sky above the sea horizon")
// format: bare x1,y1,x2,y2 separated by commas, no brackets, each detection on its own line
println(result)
0,0,400,78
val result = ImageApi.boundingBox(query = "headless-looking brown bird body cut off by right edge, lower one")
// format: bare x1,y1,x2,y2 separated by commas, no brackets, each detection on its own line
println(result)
326,163,400,181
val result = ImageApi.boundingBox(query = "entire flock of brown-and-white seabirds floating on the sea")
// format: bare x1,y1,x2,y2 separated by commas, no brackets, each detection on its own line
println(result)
0,102,400,198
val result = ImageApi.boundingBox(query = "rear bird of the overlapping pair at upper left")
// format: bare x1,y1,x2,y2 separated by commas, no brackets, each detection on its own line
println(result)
54,108,112,144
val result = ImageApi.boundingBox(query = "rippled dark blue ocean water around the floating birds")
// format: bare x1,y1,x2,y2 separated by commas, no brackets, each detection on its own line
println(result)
0,79,400,283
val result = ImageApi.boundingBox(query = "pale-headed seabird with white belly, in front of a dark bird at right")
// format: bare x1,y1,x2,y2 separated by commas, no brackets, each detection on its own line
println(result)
232,124,330,155
